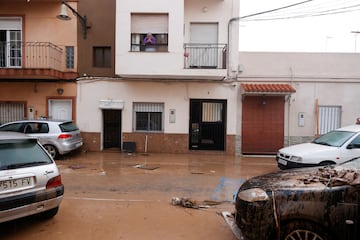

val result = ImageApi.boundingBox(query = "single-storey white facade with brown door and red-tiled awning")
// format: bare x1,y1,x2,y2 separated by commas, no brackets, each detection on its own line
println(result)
237,52,360,154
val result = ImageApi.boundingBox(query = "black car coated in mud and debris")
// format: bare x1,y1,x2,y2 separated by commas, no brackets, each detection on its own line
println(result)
235,158,360,240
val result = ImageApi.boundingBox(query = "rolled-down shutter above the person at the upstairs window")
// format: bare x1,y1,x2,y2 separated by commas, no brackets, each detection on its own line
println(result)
131,13,169,33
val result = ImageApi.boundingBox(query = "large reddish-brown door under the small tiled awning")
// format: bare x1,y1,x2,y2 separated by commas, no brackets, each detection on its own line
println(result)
242,96,285,154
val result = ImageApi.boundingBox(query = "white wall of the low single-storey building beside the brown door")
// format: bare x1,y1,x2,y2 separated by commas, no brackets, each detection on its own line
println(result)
238,52,360,141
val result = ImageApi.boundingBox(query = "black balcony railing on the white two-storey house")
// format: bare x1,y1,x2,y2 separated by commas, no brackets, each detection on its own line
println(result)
184,43,227,69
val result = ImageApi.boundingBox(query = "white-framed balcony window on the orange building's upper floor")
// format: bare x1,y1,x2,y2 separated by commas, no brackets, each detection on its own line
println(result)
0,17,22,67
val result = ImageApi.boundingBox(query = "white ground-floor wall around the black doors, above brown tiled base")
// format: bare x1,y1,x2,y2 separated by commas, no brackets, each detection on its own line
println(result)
77,78,238,134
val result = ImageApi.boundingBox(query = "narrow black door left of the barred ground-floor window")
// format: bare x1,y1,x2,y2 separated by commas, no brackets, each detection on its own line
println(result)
103,109,121,149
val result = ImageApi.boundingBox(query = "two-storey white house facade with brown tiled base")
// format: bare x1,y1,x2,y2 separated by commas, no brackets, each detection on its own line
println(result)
77,0,239,154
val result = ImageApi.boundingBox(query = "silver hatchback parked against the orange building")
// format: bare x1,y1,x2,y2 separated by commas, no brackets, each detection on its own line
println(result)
0,119,83,159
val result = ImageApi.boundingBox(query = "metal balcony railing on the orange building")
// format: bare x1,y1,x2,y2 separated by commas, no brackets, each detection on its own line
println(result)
0,41,63,71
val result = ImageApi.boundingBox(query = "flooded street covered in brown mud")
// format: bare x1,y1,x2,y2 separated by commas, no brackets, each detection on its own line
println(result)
0,152,277,240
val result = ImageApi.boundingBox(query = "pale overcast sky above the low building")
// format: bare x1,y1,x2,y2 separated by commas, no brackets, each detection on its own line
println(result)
239,0,360,52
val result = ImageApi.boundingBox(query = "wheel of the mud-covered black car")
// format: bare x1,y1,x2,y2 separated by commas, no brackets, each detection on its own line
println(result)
281,221,332,240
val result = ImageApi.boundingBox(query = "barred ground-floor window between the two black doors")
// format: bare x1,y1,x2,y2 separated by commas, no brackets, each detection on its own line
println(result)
134,103,164,132
